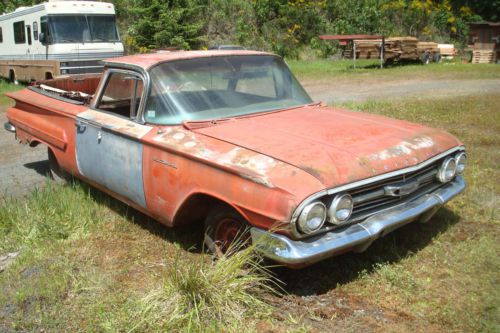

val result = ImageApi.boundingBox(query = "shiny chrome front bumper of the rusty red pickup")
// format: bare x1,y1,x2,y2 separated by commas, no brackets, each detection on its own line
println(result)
251,176,465,266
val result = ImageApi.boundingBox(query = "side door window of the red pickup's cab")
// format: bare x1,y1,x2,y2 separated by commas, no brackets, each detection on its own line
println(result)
97,72,143,119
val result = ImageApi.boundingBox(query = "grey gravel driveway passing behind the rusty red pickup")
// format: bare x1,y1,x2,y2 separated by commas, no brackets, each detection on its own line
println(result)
0,78,500,197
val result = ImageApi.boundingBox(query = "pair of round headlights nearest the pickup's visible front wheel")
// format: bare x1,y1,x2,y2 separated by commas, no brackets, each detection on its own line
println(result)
298,193,354,234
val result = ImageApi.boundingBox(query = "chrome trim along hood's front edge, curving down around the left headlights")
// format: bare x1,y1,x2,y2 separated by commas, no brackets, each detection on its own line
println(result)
290,146,465,238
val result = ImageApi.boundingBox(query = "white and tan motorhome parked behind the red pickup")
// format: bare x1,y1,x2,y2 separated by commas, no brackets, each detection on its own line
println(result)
0,0,123,82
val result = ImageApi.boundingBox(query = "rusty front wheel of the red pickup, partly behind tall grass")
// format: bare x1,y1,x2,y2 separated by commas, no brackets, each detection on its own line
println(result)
204,206,250,257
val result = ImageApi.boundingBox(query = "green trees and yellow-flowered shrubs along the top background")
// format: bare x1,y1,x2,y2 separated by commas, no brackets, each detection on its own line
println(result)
0,0,494,58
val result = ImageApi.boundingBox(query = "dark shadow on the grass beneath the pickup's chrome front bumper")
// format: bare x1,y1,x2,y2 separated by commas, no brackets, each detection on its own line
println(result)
273,207,460,296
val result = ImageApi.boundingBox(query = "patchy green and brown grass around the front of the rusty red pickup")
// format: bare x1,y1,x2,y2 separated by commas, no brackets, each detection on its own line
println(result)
0,63,500,332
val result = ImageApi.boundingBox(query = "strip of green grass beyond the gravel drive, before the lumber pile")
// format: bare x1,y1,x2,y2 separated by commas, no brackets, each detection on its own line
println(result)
287,60,500,80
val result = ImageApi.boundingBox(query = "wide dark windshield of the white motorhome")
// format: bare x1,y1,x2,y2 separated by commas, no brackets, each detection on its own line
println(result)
49,15,119,43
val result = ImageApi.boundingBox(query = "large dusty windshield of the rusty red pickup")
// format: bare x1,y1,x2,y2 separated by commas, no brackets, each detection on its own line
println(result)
144,56,312,125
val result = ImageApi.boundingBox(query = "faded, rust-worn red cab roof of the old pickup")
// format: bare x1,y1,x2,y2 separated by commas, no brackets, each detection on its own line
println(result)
104,50,273,70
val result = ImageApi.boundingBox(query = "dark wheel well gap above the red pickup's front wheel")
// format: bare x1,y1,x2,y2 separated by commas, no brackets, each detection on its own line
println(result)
173,193,244,225
